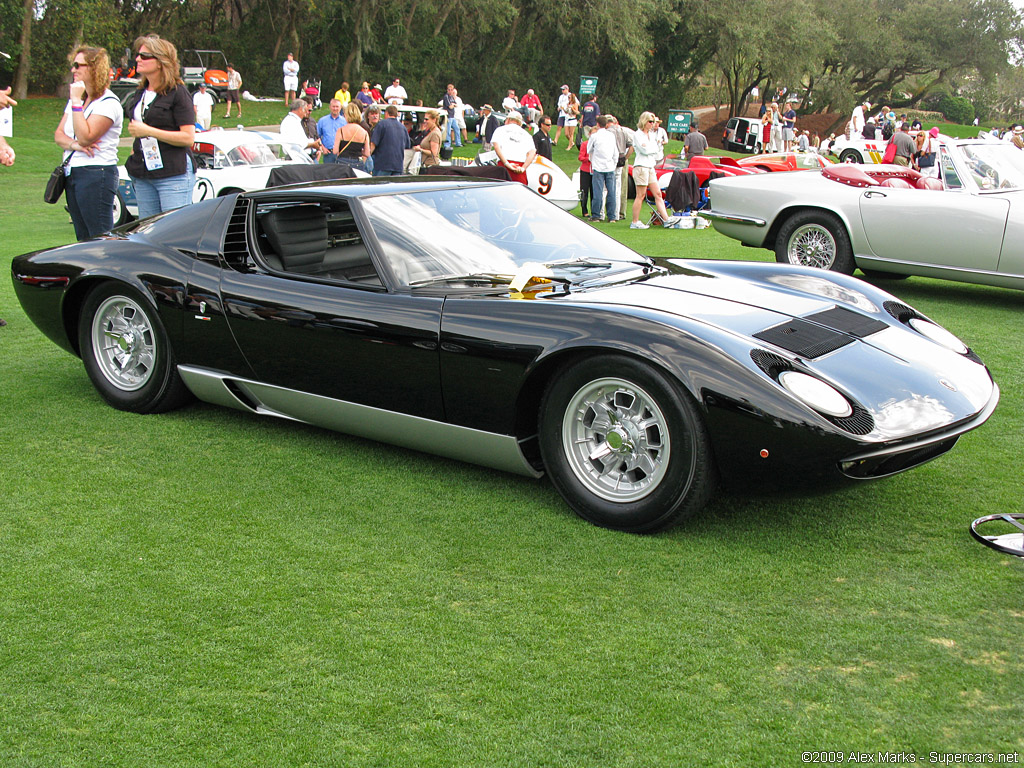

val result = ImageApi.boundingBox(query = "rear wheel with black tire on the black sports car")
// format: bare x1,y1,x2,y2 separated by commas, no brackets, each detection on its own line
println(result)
78,282,189,414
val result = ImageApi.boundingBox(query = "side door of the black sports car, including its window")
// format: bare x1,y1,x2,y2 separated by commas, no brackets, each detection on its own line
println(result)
220,194,443,420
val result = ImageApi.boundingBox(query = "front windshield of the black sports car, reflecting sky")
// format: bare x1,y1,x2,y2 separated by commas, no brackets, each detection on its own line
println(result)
362,184,648,287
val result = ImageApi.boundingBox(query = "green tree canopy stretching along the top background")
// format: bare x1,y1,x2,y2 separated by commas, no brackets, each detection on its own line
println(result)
0,0,1022,118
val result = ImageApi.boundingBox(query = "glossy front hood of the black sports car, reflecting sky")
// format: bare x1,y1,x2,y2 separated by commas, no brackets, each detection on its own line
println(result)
566,265,997,440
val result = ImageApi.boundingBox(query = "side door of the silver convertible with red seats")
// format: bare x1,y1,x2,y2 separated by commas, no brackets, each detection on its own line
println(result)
860,156,1010,271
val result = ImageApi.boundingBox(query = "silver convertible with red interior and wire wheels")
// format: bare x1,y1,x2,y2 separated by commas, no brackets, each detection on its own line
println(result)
701,132,1024,290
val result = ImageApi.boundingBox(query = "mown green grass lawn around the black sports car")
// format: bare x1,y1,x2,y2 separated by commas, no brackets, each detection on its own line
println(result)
0,99,1024,768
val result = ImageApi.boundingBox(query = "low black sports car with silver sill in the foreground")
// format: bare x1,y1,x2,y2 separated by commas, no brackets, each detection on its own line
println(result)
12,178,998,531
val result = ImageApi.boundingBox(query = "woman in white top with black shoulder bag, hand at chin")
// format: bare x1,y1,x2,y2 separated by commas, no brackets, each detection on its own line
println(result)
53,45,124,241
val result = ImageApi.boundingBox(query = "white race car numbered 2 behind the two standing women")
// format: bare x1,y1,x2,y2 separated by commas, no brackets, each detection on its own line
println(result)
114,130,313,226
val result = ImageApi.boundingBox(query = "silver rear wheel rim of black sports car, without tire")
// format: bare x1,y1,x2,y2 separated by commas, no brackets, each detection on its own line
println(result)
92,296,157,392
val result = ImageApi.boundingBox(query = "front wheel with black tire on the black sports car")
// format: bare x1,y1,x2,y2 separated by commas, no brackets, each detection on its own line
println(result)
540,355,715,534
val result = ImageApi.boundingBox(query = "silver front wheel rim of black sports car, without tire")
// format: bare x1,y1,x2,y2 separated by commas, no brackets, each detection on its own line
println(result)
562,378,671,502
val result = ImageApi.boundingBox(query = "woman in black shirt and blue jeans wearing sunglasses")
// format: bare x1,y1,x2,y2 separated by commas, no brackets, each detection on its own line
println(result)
125,35,196,218
